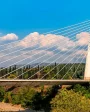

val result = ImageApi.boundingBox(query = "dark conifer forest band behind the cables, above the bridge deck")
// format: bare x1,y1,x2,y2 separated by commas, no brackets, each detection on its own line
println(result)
0,63,85,79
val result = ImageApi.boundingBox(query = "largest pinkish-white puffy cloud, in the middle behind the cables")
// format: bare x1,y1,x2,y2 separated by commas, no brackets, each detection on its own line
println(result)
19,32,75,51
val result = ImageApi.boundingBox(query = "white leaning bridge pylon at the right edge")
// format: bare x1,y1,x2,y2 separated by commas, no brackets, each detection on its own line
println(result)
84,42,90,80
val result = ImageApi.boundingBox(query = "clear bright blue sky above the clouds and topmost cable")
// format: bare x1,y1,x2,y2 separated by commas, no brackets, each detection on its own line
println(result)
0,0,90,38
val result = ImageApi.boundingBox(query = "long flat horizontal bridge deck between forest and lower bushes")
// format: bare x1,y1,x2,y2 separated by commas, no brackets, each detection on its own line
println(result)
0,79,90,86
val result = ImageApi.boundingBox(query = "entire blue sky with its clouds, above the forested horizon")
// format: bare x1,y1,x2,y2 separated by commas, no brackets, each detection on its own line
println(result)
0,0,90,66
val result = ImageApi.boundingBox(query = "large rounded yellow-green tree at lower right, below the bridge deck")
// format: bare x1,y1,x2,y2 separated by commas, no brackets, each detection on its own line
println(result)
51,89,90,112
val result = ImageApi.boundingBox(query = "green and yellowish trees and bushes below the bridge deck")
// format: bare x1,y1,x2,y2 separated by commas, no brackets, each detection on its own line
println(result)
0,84,90,112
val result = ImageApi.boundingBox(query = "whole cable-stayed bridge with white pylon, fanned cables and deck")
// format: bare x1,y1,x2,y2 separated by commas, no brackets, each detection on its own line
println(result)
0,20,90,85
